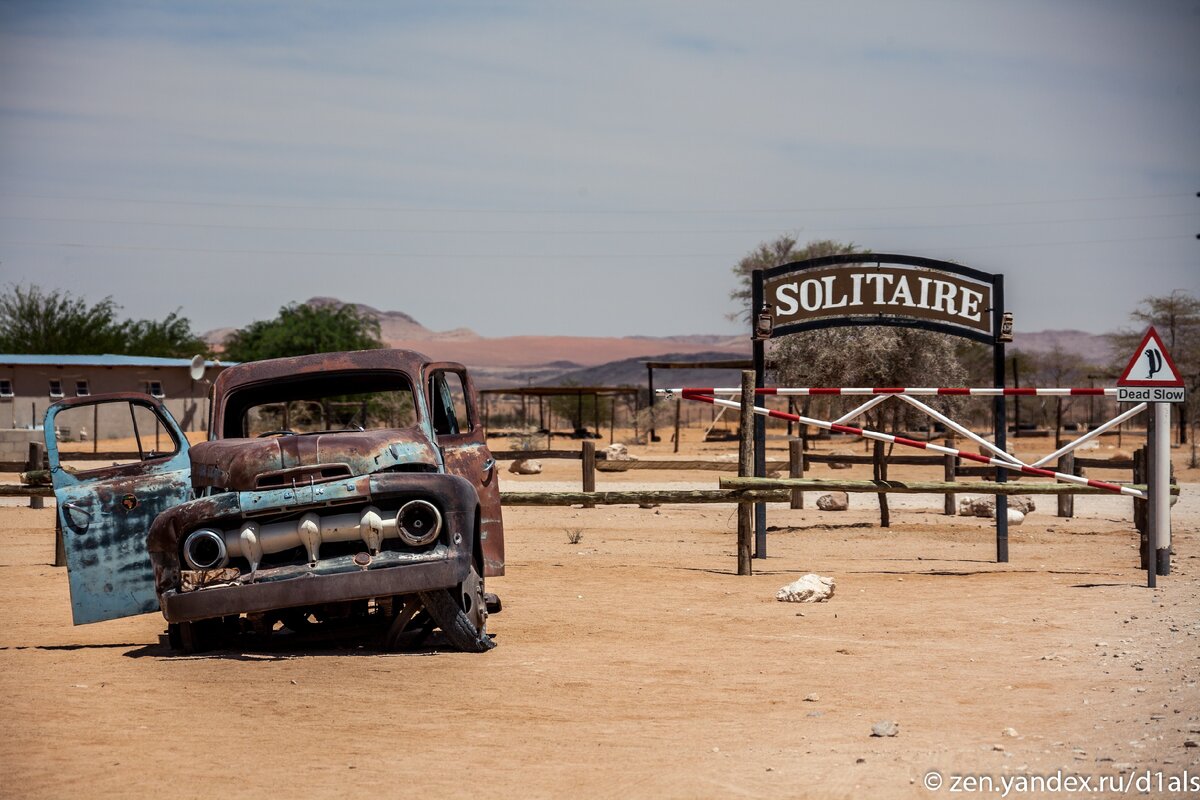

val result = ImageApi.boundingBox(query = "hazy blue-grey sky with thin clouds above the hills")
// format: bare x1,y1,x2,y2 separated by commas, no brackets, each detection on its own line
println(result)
0,0,1200,336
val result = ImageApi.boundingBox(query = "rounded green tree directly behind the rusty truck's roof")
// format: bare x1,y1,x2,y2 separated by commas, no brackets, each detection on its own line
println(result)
224,303,383,361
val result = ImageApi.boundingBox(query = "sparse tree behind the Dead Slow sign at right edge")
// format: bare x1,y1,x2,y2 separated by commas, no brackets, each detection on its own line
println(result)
1109,289,1200,467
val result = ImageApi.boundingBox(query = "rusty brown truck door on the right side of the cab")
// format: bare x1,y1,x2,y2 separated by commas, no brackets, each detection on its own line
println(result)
425,361,504,578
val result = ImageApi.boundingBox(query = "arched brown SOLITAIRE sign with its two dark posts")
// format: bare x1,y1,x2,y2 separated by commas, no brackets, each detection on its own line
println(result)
750,253,1013,561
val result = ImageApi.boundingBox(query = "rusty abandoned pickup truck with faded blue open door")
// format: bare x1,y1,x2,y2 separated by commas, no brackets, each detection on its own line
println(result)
46,350,504,652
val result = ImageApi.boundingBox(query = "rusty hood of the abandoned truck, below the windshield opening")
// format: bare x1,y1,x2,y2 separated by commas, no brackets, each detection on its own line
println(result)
190,428,439,492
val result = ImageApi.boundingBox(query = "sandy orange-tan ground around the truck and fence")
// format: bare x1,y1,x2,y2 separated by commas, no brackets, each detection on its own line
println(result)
0,431,1200,799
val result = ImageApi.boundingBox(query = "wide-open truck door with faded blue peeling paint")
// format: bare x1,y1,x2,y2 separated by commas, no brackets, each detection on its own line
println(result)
46,392,192,625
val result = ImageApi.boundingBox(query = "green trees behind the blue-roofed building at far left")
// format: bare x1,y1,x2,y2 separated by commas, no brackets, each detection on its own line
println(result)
0,285,208,357
